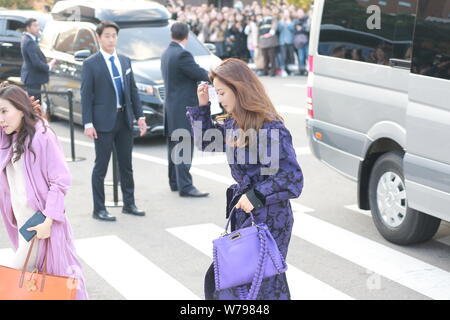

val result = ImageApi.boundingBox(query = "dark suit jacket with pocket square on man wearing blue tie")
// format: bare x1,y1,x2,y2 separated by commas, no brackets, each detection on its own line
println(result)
81,52,144,132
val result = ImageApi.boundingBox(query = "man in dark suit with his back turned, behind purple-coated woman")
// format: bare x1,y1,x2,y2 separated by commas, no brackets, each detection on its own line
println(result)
161,22,208,197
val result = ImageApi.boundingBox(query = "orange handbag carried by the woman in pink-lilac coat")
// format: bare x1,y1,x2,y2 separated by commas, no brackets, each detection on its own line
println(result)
0,237,78,300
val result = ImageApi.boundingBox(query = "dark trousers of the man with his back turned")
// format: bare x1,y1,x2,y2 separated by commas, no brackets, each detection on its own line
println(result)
167,135,194,192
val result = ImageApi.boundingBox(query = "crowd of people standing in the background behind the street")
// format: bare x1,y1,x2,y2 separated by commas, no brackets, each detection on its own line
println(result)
167,0,311,76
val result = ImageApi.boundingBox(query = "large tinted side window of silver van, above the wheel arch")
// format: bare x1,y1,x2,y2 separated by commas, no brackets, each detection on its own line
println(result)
318,0,417,65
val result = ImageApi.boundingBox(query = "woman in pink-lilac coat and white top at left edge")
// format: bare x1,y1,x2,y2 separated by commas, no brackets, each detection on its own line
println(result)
0,86,88,299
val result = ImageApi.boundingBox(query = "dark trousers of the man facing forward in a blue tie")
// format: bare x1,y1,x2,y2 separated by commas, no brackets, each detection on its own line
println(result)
92,111,135,212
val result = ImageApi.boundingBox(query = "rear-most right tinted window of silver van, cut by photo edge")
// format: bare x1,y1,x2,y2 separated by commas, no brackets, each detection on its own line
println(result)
411,0,450,80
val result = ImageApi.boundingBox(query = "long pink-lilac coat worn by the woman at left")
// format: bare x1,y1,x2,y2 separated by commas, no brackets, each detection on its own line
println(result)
0,121,87,299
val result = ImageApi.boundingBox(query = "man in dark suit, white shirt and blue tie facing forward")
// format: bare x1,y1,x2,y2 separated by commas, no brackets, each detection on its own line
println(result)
81,21,147,221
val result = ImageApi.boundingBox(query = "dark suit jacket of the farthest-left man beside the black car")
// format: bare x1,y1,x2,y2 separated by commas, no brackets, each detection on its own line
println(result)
20,34,49,85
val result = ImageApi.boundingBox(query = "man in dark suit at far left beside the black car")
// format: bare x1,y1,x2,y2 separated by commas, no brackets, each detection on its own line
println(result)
20,18,56,104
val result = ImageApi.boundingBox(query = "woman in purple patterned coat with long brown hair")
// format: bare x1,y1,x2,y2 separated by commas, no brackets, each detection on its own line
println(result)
187,59,303,300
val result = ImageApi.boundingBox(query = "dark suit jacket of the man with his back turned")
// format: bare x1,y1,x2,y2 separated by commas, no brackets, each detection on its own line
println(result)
161,42,209,135
